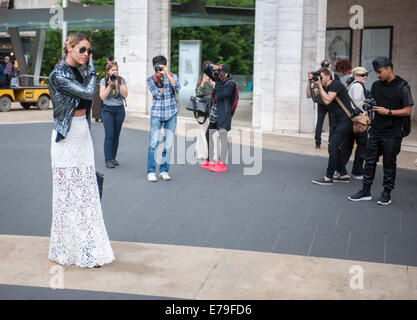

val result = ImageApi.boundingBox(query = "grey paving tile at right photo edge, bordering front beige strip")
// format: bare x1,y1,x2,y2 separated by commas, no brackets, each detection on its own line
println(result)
386,233,417,266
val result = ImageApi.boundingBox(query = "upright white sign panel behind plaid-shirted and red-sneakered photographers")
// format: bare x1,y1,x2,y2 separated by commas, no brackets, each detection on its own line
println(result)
178,40,202,107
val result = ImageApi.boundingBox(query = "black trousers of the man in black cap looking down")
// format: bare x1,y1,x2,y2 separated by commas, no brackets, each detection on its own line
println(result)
363,136,403,190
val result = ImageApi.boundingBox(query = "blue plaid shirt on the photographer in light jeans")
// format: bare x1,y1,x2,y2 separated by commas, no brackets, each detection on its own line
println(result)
146,74,181,121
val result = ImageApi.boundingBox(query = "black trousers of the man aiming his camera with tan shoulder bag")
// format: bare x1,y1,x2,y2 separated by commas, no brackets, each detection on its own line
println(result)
326,121,352,179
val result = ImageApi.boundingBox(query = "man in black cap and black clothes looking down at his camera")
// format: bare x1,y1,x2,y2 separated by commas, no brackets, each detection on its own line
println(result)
349,57,414,206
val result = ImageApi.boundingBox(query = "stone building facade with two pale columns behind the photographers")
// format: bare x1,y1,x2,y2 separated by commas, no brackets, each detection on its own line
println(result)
115,0,417,133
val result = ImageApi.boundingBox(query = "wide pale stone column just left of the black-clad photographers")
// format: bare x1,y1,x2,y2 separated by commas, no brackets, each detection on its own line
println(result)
253,0,327,133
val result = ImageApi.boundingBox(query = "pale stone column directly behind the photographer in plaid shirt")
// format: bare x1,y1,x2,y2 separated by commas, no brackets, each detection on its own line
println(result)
114,0,171,116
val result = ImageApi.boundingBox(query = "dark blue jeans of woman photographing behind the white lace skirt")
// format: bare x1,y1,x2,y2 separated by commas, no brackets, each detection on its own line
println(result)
101,104,125,162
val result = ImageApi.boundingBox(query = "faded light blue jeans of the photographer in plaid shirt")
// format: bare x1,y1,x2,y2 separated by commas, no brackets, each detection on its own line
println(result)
147,115,177,173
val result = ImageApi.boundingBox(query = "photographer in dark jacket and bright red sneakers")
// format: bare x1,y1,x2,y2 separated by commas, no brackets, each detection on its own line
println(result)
202,64,236,172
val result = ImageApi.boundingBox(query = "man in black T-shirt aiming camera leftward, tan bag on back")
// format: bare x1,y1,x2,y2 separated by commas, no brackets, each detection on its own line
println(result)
307,68,361,186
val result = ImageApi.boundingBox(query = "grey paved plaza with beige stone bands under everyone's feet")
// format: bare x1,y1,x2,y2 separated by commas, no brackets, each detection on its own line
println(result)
0,110,417,299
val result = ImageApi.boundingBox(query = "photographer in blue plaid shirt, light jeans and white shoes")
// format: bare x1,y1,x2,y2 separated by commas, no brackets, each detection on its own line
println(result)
146,56,181,182
